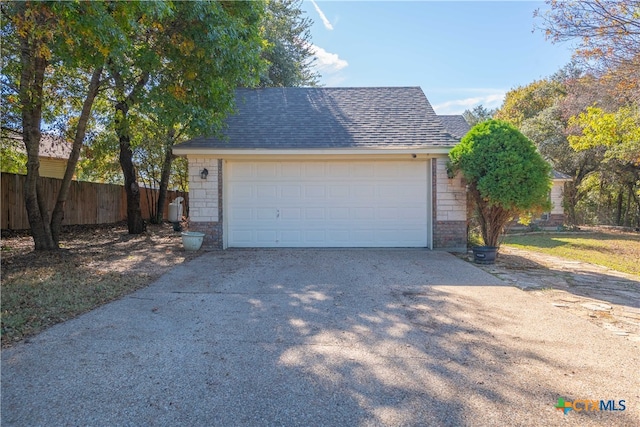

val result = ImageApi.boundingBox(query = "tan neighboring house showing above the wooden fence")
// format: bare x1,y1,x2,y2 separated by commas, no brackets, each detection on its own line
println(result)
3,129,72,179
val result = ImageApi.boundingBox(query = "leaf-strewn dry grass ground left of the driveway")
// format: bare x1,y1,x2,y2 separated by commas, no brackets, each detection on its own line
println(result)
0,224,198,347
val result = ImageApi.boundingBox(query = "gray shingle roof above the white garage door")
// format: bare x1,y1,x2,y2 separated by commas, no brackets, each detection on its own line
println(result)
174,87,459,149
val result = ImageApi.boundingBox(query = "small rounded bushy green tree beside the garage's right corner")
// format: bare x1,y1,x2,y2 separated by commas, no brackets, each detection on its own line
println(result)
449,120,551,247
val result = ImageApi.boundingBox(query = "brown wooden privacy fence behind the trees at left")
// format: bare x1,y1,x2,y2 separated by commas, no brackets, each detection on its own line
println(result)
0,173,188,230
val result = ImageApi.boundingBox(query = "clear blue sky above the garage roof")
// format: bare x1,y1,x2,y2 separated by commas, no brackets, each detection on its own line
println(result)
302,0,572,114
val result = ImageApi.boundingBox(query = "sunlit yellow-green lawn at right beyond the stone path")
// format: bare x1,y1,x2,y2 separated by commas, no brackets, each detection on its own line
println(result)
502,232,640,276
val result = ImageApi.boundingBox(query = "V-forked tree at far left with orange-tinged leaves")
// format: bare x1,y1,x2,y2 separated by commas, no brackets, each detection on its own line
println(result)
1,2,111,250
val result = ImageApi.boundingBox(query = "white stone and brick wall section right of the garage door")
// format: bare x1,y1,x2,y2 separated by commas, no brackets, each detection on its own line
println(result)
431,157,467,251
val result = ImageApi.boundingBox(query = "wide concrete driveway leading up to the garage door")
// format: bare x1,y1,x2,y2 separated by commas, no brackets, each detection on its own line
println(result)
2,250,640,426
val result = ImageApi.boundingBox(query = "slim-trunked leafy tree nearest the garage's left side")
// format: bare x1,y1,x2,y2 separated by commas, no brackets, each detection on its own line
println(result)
138,2,265,226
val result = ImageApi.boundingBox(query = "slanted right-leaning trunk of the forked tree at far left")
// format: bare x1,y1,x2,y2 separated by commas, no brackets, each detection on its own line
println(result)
51,66,102,245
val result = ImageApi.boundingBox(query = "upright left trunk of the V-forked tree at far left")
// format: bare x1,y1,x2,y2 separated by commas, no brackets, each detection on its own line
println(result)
19,16,58,251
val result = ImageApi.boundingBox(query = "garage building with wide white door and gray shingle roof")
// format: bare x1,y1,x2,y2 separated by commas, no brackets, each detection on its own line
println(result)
173,87,467,250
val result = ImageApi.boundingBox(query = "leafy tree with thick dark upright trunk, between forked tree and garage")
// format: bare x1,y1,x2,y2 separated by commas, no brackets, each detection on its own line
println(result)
97,1,264,234
